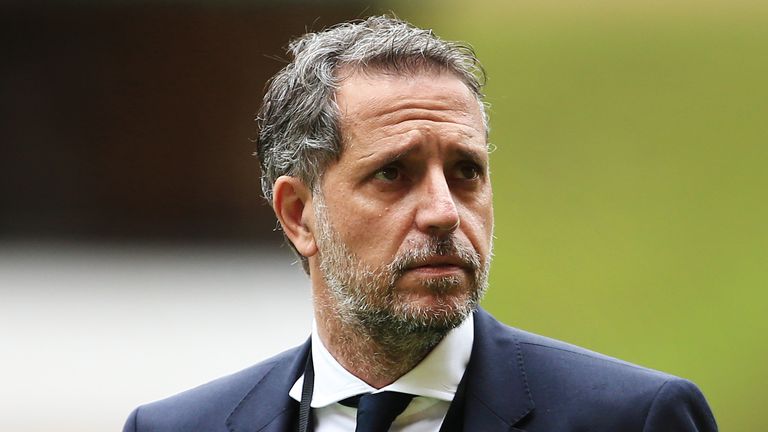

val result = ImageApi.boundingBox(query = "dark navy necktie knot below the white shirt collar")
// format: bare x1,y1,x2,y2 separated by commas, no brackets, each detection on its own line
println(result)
355,391,413,432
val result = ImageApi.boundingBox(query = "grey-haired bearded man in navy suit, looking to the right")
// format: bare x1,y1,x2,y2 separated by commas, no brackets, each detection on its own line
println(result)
125,17,717,432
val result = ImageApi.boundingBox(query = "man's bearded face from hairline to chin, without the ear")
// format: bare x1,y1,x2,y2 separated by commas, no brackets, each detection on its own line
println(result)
313,72,493,333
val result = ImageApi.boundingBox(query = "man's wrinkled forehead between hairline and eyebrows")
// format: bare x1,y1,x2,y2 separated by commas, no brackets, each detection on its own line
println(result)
335,71,486,159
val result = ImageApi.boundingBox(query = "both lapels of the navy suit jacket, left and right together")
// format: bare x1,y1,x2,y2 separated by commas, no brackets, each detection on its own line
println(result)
227,309,534,432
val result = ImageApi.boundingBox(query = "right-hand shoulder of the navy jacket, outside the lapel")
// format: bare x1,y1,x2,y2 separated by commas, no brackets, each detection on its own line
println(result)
478,313,717,431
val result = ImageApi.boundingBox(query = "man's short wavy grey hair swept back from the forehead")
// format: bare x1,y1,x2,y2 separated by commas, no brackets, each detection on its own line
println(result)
256,16,488,270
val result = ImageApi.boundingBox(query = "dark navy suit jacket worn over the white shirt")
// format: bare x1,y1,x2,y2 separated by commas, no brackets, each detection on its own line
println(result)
124,310,717,432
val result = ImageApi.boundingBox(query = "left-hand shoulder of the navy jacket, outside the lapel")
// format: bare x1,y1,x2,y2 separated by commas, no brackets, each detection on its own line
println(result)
123,346,305,432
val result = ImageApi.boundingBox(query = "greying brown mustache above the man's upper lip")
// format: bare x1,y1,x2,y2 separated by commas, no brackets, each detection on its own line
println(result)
387,236,481,275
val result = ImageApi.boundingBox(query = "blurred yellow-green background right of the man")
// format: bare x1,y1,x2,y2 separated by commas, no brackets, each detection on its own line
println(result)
393,0,768,431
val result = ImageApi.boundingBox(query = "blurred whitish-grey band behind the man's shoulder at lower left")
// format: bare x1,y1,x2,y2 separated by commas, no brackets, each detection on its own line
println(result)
0,243,312,432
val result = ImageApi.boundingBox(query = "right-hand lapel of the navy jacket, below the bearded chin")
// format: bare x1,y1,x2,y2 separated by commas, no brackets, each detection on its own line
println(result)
464,309,534,432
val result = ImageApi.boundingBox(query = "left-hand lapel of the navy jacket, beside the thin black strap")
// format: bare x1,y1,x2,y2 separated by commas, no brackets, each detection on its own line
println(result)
227,341,309,432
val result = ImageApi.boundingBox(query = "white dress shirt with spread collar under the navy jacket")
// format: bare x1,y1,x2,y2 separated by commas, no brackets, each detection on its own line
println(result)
289,316,474,432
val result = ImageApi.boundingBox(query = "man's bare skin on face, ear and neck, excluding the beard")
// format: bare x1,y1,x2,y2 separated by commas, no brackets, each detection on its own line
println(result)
274,71,493,388
